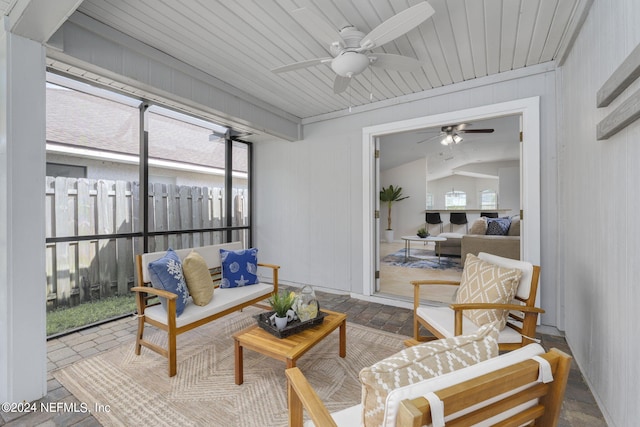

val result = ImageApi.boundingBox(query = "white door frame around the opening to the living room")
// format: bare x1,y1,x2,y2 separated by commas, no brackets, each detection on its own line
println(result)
362,96,540,297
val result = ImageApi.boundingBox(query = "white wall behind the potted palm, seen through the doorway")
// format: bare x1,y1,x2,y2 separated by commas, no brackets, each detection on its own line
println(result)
379,158,427,241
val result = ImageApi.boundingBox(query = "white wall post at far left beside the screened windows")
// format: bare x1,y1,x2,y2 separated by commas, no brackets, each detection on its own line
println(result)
0,28,47,403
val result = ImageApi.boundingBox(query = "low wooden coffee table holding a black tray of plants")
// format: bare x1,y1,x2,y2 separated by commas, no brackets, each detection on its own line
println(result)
233,310,347,385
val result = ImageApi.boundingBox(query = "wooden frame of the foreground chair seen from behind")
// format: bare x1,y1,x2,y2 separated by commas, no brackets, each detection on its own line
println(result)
286,349,571,427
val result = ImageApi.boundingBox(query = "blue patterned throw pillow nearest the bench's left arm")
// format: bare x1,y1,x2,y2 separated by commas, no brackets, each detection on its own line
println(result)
149,248,189,316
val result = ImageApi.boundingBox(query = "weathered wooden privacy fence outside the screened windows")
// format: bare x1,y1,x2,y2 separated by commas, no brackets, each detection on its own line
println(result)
45,177,247,309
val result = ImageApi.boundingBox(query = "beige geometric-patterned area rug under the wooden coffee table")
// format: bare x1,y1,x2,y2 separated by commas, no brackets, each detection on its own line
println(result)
53,307,407,427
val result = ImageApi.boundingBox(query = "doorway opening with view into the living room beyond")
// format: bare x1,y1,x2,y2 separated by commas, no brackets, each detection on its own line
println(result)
377,115,521,303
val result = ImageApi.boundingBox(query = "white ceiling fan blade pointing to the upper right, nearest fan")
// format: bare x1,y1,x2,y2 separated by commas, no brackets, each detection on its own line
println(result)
360,1,435,50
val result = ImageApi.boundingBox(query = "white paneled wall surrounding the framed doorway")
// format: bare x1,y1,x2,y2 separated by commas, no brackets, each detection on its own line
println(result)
254,67,558,325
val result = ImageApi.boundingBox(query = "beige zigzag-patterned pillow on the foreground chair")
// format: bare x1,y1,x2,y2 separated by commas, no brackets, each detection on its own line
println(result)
360,324,498,427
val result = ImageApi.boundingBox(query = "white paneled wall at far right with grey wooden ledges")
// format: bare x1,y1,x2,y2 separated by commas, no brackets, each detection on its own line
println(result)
556,0,640,426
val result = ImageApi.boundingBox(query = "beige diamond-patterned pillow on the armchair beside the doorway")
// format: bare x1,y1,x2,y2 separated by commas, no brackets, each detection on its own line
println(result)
456,254,522,330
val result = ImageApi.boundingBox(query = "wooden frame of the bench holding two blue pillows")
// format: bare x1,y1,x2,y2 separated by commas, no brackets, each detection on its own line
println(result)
131,242,280,377
